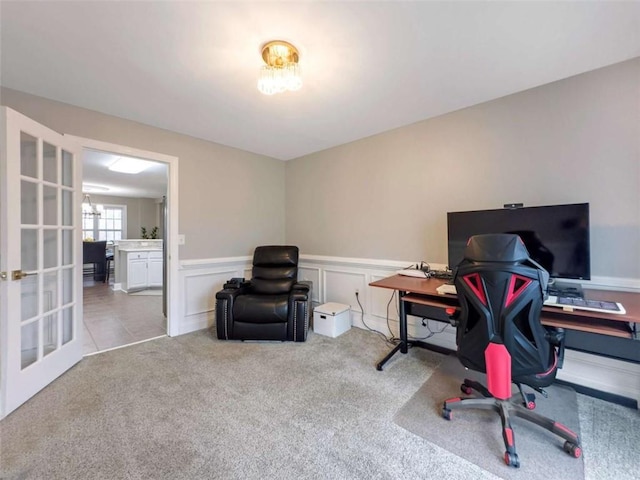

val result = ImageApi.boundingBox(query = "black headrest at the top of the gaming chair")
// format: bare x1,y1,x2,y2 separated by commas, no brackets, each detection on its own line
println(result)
464,233,529,263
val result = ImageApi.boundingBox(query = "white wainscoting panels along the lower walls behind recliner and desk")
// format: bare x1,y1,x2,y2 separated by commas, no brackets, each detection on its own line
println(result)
180,255,640,406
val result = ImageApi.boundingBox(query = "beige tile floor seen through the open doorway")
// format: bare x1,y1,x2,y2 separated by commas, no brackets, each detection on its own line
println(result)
83,276,167,355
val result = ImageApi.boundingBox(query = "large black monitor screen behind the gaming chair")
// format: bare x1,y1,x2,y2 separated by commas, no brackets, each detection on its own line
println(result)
447,203,591,280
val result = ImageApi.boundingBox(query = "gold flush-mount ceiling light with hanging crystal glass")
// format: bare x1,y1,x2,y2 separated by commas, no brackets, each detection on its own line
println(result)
258,40,302,95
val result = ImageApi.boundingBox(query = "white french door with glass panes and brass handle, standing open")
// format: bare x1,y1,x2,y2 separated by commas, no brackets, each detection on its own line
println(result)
0,107,83,419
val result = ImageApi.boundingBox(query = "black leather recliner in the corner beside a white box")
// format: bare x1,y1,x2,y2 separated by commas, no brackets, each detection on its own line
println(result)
216,245,311,342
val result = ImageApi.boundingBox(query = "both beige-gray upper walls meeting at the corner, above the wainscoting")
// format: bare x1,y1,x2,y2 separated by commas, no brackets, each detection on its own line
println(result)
0,59,640,279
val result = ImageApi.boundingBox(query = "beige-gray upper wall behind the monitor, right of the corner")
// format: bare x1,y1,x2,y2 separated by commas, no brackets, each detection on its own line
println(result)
286,59,640,279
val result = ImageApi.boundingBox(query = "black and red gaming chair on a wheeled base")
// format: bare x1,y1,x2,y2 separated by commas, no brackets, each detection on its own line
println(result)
442,234,582,467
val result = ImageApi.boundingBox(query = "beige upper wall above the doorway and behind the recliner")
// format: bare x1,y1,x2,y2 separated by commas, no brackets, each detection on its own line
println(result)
0,88,285,260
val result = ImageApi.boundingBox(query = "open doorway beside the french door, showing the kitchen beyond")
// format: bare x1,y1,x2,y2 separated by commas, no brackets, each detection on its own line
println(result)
68,138,178,355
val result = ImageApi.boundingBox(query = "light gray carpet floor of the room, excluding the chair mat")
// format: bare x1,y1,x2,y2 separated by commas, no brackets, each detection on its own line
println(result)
0,328,640,480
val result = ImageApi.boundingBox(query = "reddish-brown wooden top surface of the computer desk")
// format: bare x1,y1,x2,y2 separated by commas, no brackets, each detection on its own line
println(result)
369,275,640,323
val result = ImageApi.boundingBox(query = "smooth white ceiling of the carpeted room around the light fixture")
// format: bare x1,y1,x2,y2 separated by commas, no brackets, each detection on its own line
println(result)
0,1,640,160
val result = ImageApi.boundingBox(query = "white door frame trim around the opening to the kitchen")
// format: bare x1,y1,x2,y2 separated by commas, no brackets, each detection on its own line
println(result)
64,134,180,337
